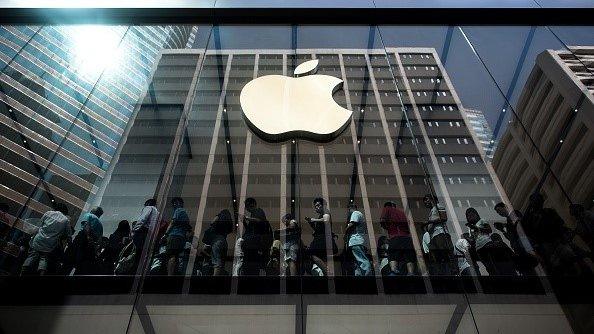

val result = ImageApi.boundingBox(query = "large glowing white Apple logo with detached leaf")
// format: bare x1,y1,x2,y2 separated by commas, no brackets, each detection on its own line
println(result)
239,59,352,142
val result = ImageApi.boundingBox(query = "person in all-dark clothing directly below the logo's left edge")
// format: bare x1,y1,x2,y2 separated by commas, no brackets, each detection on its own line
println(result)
241,197,272,276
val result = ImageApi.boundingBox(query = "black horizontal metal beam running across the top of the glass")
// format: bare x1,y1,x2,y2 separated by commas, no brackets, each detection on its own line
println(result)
0,5,594,25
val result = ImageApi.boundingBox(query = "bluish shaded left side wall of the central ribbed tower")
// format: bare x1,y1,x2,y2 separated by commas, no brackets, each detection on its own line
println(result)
93,50,199,231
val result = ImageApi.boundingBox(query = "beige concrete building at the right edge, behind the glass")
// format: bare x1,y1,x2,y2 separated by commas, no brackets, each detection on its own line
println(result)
493,47,594,221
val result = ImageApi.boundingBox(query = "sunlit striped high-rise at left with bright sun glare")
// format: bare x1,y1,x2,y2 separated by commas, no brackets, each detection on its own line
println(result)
0,26,195,266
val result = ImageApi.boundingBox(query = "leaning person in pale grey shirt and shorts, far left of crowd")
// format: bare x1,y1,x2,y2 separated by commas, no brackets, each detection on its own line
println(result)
21,203,72,275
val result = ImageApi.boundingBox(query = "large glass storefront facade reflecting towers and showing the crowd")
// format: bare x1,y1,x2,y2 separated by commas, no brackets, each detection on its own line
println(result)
0,21,594,333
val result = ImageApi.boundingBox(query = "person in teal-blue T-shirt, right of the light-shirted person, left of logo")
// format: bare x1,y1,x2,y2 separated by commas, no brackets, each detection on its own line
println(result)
165,197,192,276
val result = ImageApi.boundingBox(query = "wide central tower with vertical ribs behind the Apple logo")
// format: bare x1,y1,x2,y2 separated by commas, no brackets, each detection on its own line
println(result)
97,48,502,275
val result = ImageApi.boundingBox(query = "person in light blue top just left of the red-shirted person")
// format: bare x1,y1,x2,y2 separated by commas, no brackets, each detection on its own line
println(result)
346,204,371,276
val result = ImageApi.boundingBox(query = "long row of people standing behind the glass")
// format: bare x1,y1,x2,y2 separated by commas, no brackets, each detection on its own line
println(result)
2,193,594,276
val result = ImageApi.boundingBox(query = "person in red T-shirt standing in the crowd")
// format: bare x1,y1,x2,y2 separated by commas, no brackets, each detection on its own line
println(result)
380,202,415,275
